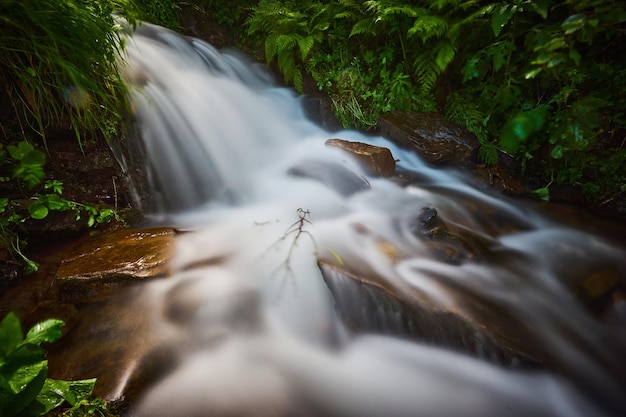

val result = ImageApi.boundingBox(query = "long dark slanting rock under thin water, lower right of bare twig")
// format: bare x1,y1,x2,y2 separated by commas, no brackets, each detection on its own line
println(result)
319,262,536,366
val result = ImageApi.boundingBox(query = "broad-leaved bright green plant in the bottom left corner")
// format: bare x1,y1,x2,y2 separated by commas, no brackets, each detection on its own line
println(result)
0,312,96,417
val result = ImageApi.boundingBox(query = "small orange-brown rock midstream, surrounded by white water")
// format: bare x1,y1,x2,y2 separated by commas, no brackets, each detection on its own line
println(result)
326,139,396,177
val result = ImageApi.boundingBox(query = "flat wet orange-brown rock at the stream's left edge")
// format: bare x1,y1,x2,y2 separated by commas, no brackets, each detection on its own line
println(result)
56,228,175,301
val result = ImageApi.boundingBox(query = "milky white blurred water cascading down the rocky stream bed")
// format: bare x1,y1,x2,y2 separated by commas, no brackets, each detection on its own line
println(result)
109,25,626,417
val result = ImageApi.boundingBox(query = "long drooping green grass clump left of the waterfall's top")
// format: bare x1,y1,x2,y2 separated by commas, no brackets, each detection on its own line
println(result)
0,0,140,146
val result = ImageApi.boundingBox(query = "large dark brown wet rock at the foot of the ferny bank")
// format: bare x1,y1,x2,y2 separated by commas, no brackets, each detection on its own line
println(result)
378,111,480,166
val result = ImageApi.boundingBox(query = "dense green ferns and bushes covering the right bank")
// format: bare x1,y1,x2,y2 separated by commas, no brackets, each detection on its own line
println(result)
248,0,626,200
